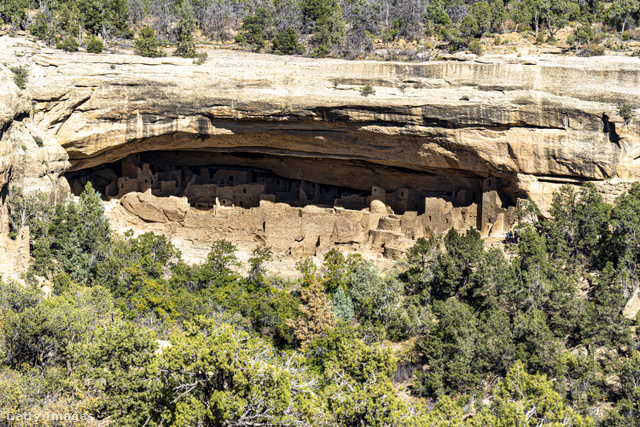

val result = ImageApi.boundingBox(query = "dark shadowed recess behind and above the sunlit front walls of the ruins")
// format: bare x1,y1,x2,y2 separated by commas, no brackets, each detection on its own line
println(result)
66,151,482,214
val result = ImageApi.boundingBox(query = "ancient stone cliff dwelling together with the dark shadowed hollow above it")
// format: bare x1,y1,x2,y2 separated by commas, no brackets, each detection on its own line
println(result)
65,151,515,259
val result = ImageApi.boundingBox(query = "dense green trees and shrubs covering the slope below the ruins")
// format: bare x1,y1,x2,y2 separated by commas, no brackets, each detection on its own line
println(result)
0,184,640,427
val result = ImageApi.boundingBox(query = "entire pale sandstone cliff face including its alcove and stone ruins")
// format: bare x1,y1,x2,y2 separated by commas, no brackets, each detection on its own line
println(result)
0,38,640,270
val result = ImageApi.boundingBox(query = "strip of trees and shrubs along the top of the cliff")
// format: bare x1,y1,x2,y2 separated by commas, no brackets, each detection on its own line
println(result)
0,0,640,58
